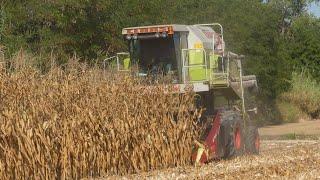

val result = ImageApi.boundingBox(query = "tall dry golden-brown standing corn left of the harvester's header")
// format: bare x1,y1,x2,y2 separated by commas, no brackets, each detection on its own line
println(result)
0,66,200,179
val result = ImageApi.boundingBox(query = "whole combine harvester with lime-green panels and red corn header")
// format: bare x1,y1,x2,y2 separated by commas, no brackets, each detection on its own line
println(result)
106,23,260,164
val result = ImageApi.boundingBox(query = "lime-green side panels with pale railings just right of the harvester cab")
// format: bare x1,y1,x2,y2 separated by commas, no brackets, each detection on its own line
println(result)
182,23,229,88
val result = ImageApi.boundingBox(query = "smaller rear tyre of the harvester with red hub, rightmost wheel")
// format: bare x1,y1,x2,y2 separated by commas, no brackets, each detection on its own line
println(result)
246,126,260,154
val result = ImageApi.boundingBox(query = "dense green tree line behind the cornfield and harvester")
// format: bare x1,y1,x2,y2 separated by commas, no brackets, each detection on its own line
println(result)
0,0,320,104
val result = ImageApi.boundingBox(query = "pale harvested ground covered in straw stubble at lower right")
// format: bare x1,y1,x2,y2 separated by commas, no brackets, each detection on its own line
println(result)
107,140,320,179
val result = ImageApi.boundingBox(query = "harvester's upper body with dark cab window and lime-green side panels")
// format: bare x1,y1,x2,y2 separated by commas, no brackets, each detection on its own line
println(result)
119,24,227,88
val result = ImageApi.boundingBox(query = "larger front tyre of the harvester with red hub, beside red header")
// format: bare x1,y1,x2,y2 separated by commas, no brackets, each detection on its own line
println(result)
223,112,245,158
